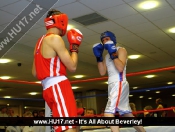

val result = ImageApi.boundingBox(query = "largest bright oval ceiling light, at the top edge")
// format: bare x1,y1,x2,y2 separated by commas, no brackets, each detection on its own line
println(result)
139,1,159,9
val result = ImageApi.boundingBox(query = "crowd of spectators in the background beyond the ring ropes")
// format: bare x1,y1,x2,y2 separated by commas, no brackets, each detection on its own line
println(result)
0,98,175,132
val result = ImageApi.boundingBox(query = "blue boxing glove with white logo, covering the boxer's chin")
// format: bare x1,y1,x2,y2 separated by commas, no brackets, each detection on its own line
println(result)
104,41,118,60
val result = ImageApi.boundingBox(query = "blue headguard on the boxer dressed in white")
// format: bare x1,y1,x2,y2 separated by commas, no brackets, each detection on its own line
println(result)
100,31,117,44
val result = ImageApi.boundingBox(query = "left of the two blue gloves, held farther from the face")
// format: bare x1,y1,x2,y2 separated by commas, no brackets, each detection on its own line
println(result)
93,43,104,62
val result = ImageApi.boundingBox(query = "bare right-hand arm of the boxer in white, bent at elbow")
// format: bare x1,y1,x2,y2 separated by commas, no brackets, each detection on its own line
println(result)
113,48,127,72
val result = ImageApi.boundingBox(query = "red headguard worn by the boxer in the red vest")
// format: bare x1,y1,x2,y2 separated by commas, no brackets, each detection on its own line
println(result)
44,14,68,36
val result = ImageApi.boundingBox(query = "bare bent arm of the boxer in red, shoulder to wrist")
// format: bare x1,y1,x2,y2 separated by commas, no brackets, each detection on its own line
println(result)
50,35,78,72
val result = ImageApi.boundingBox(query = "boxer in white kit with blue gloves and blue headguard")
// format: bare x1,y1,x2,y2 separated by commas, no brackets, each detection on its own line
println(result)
93,31,145,132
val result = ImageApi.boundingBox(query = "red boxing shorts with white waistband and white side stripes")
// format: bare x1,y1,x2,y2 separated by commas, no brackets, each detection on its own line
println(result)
42,76,77,132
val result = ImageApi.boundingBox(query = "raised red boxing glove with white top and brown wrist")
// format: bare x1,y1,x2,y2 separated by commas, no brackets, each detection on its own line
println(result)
67,29,83,53
